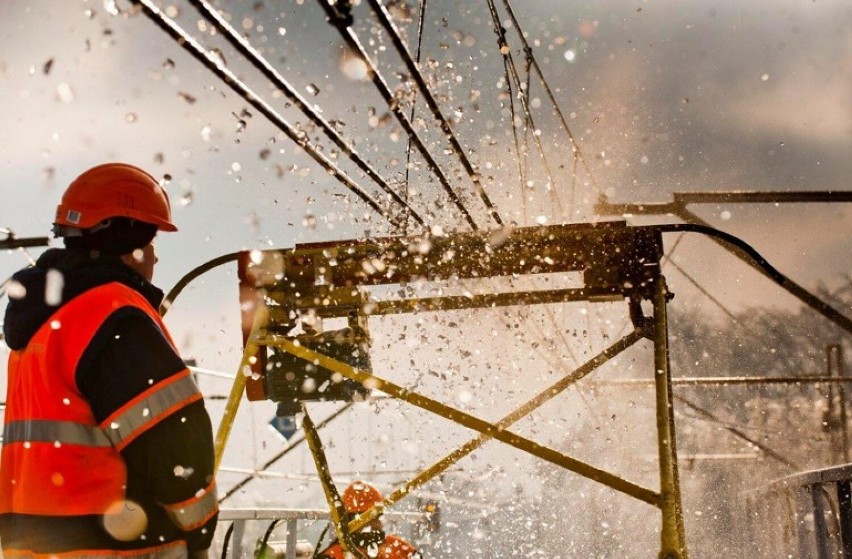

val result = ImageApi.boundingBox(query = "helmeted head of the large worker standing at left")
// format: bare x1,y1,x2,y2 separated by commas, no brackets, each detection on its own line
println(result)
53,163,177,280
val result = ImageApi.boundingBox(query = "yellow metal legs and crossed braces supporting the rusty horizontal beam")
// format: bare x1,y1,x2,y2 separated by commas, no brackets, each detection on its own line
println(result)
216,288,688,559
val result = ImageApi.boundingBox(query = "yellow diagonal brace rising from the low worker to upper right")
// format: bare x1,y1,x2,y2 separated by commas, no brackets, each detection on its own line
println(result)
349,329,659,532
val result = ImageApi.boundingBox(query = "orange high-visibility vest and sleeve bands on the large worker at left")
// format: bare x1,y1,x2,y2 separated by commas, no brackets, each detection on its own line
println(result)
0,283,217,530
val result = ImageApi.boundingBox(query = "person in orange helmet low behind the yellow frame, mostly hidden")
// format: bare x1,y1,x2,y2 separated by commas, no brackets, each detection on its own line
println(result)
315,481,420,559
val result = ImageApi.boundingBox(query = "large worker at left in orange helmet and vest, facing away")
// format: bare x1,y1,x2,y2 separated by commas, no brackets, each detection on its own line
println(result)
0,163,218,559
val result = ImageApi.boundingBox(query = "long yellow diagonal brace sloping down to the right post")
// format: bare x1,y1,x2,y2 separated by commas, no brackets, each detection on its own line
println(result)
261,335,660,506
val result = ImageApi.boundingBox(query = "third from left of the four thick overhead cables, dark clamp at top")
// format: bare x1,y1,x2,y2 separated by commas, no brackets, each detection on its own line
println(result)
320,0,479,231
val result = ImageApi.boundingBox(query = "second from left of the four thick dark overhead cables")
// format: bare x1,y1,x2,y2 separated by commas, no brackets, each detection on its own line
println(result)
189,0,425,230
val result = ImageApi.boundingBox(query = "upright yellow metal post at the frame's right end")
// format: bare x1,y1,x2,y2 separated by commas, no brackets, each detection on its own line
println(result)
653,274,689,559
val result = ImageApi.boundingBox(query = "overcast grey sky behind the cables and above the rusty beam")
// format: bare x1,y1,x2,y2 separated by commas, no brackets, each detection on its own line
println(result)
0,0,852,544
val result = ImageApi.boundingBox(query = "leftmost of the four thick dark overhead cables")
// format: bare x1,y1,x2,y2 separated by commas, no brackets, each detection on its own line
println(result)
130,0,402,227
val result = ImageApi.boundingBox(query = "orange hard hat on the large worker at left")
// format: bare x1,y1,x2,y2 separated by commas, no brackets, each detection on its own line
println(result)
56,163,177,231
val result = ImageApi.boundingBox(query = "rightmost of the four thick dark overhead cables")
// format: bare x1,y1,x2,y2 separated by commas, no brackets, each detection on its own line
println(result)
369,0,503,229
